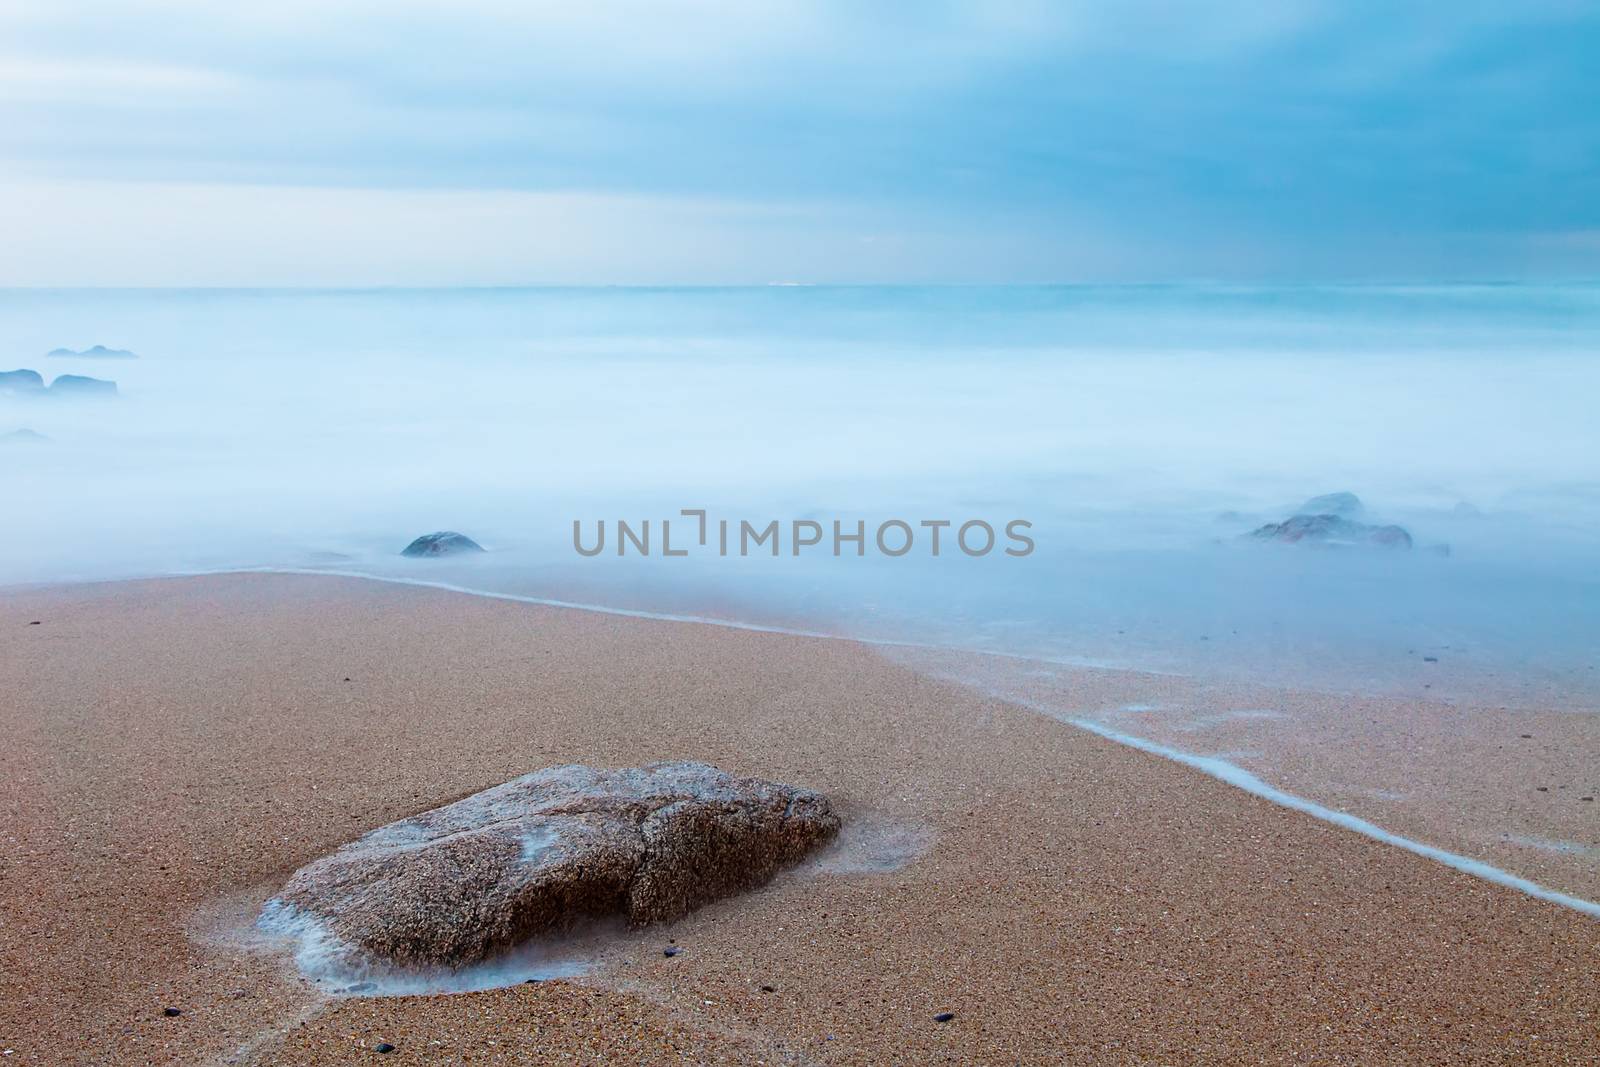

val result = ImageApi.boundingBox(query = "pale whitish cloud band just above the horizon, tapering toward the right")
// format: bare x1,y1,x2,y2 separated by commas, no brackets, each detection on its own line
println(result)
0,181,1164,286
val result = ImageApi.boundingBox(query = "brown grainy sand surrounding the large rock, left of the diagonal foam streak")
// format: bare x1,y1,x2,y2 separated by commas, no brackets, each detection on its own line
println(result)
0,576,1600,1064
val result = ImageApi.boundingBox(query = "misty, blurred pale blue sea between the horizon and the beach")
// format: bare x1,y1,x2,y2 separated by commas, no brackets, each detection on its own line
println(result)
0,286,1600,707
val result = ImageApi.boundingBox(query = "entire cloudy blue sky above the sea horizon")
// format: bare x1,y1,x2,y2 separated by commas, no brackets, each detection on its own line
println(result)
0,0,1600,285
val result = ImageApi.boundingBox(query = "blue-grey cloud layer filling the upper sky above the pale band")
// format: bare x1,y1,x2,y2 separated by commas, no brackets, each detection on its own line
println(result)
0,0,1600,280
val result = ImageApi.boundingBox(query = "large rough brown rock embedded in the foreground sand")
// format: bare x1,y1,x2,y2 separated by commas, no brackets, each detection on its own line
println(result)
266,763,838,966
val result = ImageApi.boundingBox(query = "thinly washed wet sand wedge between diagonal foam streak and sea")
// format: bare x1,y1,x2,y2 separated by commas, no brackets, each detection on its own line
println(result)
891,649,1600,901
